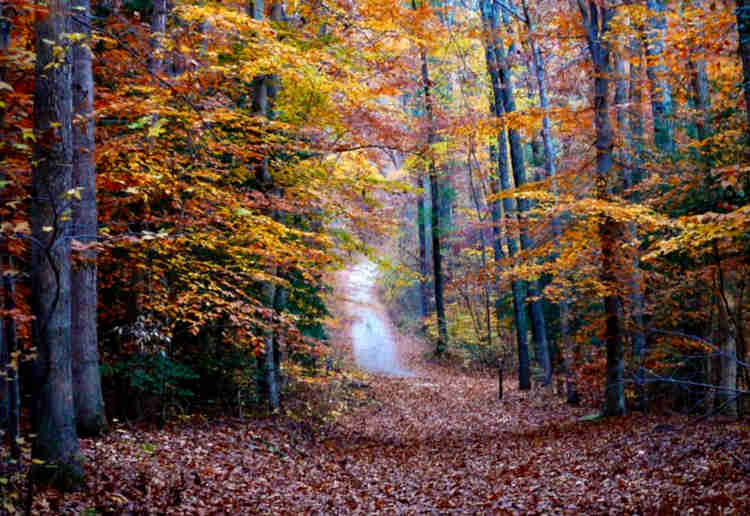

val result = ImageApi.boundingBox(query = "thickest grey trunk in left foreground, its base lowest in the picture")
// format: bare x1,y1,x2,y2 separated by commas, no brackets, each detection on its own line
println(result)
31,0,83,488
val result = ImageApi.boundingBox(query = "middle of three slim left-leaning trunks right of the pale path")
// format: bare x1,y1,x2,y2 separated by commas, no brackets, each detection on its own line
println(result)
491,0,552,385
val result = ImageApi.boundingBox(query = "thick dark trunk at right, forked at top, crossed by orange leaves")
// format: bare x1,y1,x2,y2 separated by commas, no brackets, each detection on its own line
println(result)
577,0,625,416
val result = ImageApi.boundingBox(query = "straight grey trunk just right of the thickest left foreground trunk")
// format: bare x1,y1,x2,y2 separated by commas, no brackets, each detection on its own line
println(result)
71,0,107,436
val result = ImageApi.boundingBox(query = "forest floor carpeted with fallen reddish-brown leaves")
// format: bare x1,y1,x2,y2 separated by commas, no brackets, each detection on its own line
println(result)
27,264,750,515
